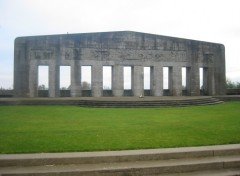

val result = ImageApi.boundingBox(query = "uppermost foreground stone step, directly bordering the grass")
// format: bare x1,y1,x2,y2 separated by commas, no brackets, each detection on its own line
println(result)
0,144,240,167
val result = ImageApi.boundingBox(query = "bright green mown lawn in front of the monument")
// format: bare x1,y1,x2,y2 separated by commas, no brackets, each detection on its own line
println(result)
0,102,240,153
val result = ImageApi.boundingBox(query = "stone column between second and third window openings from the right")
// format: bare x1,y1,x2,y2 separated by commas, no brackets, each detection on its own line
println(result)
172,66,182,96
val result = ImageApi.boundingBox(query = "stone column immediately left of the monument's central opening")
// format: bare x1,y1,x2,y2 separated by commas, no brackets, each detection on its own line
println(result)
112,65,123,97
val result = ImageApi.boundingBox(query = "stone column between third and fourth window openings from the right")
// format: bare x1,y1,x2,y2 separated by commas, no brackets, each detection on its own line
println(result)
150,66,163,96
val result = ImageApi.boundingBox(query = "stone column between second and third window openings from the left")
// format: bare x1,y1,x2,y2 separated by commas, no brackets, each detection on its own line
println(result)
70,61,82,97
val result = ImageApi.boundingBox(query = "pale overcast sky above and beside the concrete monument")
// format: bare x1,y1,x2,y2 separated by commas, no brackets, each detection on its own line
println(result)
0,0,240,88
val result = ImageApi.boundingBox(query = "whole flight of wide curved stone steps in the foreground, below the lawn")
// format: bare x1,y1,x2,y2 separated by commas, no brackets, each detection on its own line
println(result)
0,144,240,176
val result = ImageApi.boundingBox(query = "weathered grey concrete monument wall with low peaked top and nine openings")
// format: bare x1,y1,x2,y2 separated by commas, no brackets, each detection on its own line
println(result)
14,31,226,97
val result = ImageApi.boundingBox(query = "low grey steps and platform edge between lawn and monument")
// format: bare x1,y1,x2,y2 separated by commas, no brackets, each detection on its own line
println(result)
0,97,223,108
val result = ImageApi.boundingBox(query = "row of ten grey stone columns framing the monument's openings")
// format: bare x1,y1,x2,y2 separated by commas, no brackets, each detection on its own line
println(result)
29,62,214,97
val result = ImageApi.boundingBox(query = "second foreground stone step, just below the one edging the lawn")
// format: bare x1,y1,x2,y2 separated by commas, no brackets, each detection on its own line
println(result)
0,155,240,176
